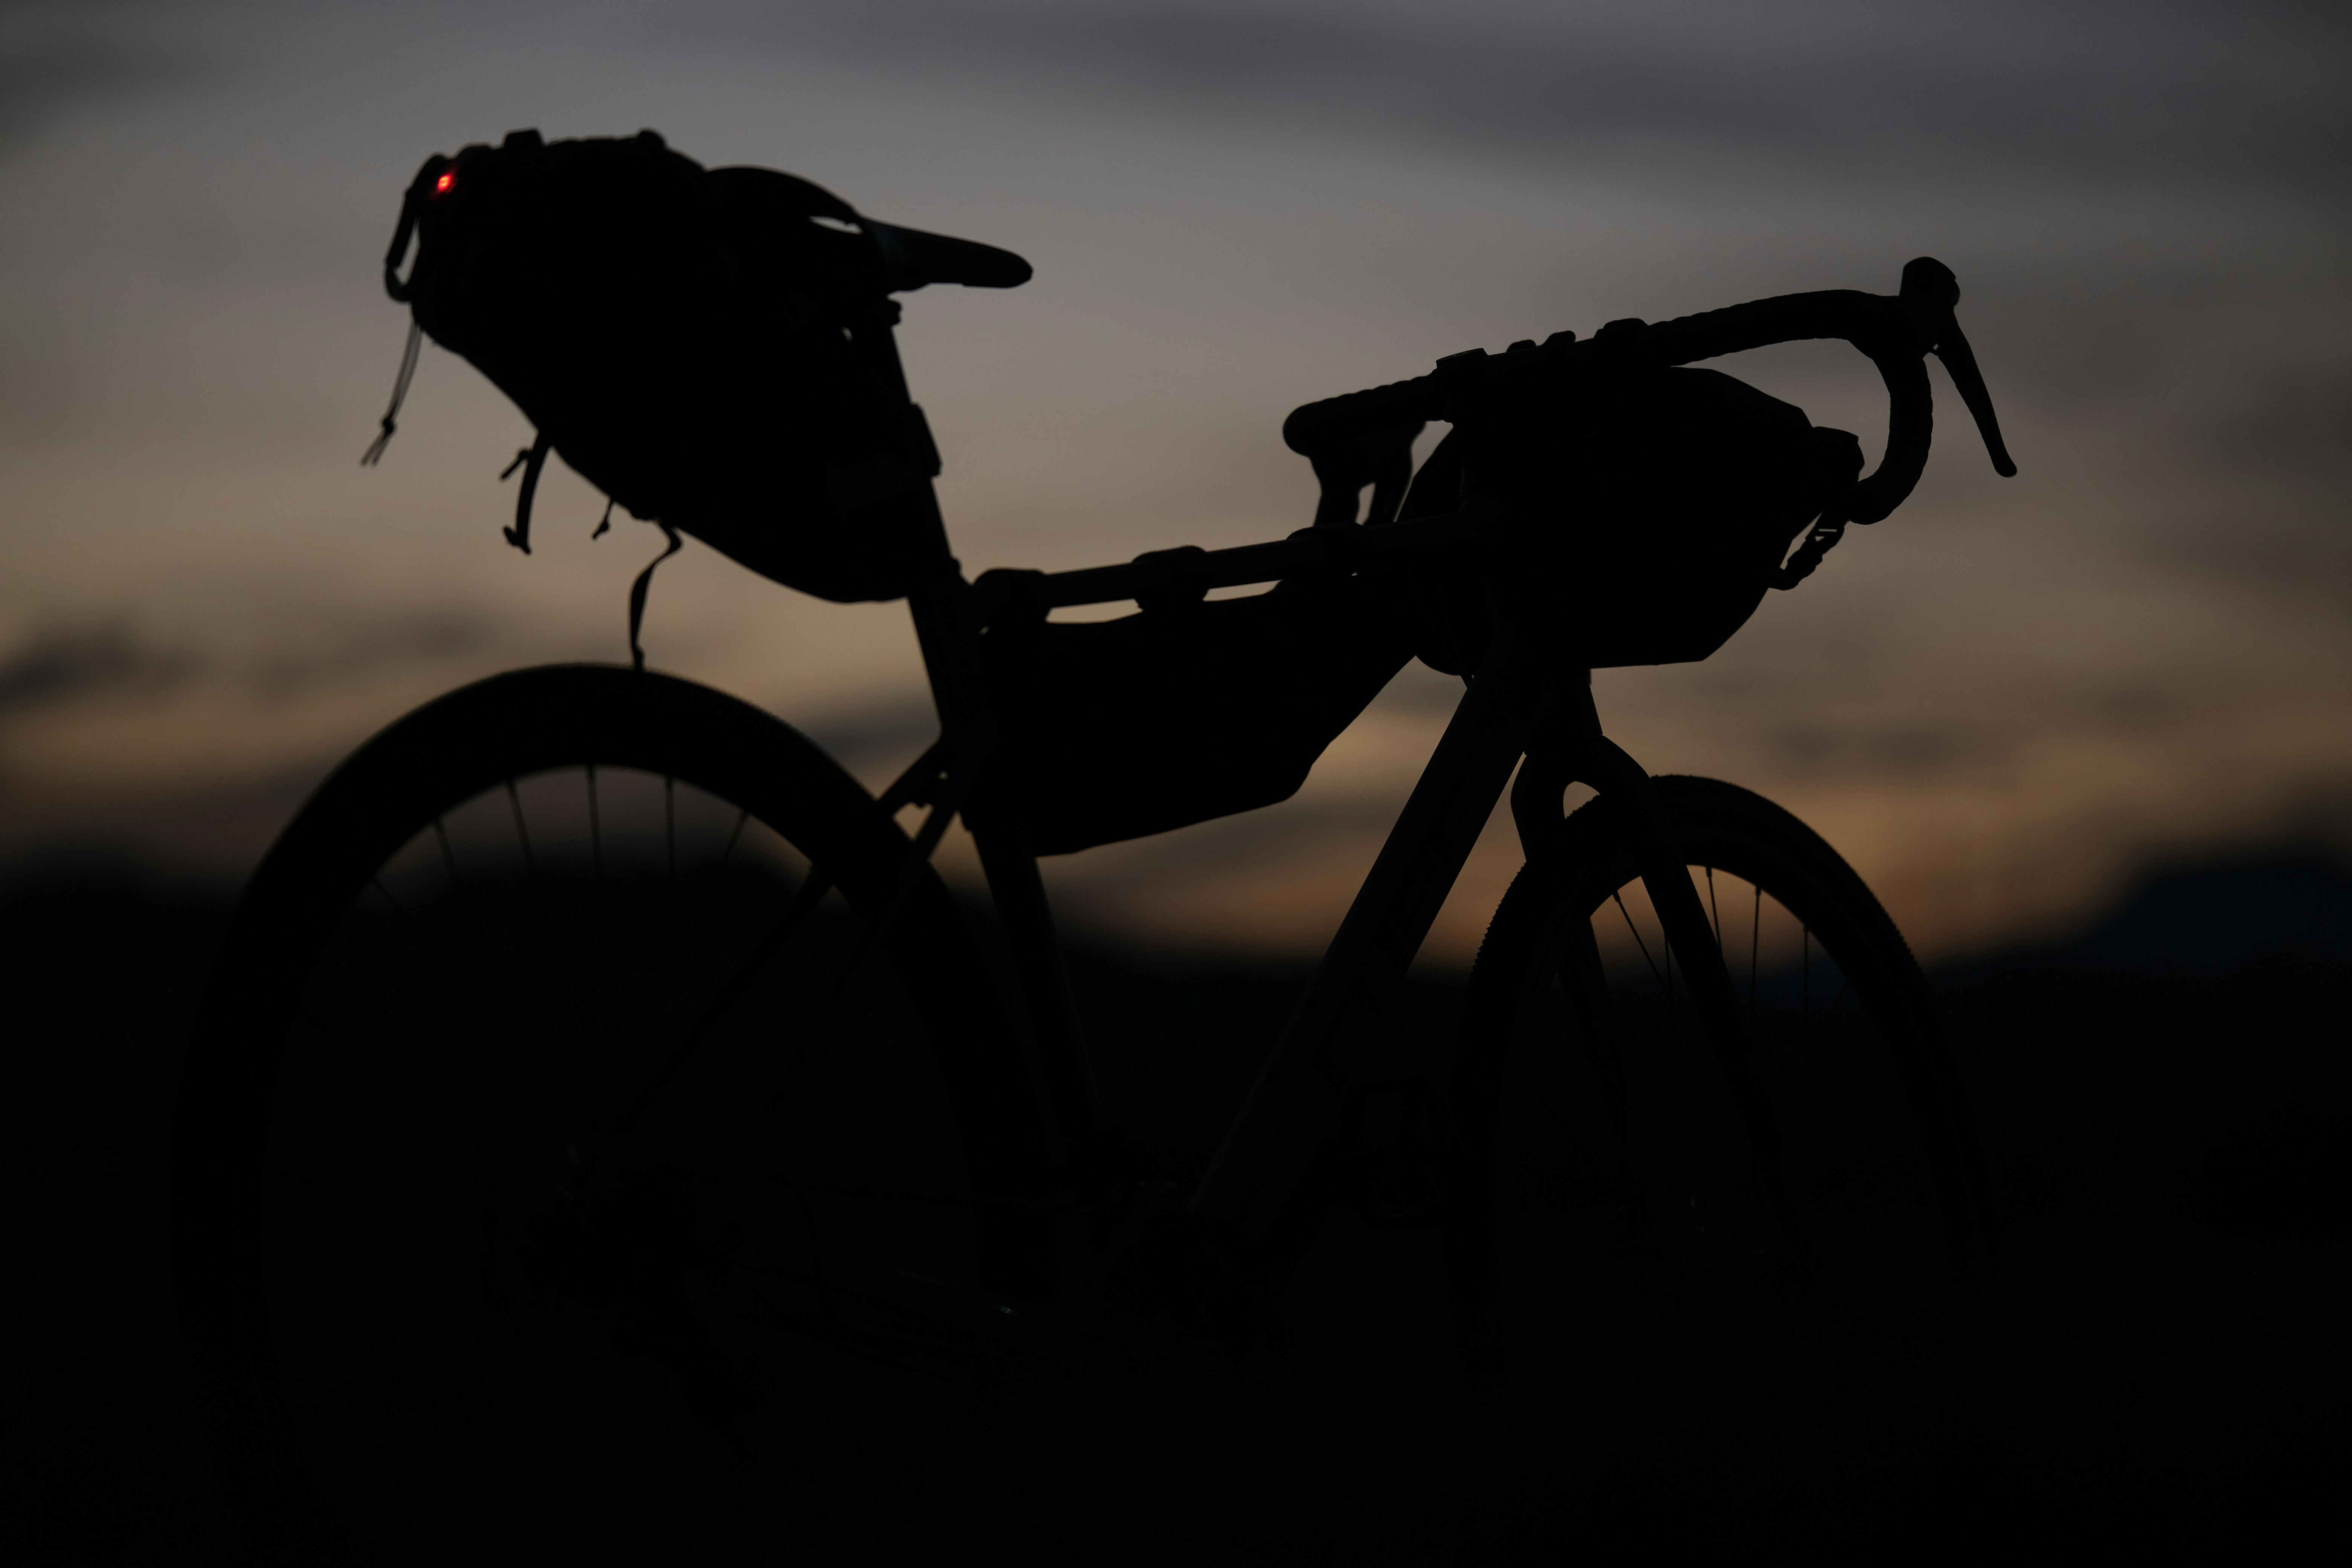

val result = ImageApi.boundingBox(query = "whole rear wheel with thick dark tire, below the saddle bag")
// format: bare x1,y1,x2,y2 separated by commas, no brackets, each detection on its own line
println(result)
176,668,1049,1523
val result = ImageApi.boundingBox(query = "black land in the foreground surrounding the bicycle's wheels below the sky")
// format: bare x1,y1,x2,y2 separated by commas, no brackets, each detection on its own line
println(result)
0,863,2352,1561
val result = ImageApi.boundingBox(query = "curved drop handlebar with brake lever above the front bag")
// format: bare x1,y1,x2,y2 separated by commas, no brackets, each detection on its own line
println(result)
1282,256,2018,522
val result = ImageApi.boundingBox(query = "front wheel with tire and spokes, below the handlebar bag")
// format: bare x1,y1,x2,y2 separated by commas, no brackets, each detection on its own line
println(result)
1444,776,1978,1357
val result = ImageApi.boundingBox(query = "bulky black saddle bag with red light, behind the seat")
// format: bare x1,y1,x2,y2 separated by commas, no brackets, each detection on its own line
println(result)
388,132,939,599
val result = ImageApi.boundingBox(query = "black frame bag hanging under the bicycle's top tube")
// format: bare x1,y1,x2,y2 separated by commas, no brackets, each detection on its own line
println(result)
971,574,1416,856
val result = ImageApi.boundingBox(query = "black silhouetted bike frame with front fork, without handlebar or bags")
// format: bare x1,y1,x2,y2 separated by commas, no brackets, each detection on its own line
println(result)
865,400,1771,1283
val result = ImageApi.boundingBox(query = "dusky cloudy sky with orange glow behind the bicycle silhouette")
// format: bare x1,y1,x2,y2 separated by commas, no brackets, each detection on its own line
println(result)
0,0,2352,964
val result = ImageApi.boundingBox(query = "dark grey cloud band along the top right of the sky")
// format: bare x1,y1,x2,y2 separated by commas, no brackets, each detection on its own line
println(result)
666,0,2352,186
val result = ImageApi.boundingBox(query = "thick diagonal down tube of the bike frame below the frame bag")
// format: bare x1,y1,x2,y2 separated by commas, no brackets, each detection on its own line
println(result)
1190,637,1527,1237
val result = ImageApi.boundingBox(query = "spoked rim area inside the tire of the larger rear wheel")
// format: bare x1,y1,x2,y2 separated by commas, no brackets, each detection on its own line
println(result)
273,764,971,1458
